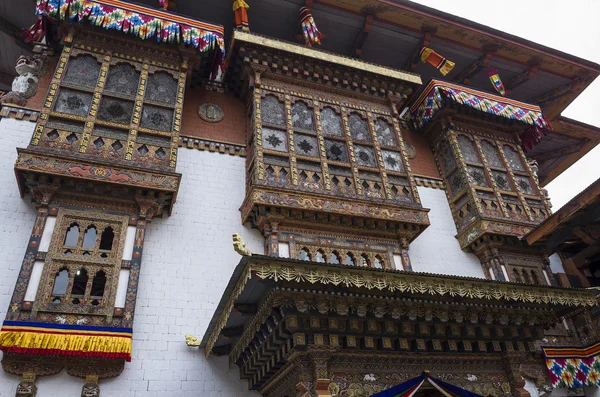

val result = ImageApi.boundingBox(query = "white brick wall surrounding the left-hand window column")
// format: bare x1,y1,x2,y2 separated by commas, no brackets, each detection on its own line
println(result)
0,119,264,397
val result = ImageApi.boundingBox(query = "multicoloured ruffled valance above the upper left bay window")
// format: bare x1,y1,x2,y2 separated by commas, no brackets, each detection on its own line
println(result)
31,0,225,59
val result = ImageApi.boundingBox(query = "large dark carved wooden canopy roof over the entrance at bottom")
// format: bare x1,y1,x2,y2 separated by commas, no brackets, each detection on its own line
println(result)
201,255,596,388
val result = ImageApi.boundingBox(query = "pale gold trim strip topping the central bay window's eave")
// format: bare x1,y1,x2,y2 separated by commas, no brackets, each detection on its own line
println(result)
232,30,423,85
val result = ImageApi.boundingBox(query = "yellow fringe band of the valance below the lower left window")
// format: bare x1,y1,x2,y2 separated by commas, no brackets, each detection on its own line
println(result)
0,331,131,354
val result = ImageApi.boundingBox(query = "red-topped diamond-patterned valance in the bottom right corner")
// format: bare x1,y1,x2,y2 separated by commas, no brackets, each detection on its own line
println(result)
542,342,600,389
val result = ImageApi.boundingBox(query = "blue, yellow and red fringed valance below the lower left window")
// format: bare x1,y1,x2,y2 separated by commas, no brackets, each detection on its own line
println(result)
0,321,132,361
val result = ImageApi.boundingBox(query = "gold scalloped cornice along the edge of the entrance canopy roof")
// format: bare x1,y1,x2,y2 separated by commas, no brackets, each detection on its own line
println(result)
203,255,597,356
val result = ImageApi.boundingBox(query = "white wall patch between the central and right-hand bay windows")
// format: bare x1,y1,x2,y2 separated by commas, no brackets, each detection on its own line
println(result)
408,186,485,278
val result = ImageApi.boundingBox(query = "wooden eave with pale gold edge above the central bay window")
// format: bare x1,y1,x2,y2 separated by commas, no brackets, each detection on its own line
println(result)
225,30,421,108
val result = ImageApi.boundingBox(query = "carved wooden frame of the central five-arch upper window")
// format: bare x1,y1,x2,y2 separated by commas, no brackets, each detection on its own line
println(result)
248,85,420,204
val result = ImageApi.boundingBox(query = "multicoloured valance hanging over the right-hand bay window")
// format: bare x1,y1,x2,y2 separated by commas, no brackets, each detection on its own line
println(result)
410,80,551,150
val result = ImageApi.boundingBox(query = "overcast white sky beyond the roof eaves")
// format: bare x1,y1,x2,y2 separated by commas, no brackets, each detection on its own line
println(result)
416,0,600,211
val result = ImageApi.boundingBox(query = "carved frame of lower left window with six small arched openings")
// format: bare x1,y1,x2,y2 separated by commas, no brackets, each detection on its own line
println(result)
33,208,129,317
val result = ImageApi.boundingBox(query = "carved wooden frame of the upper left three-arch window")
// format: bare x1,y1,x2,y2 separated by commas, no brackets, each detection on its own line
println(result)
31,37,186,171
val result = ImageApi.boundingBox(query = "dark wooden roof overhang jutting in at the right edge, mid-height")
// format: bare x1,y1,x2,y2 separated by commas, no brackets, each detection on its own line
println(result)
524,179,600,260
